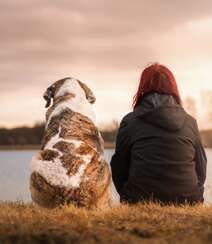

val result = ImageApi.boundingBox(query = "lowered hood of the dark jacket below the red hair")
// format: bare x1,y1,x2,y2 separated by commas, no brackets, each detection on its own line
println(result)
134,93,186,131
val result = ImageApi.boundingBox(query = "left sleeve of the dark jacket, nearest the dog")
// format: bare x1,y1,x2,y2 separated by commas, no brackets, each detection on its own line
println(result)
110,117,130,194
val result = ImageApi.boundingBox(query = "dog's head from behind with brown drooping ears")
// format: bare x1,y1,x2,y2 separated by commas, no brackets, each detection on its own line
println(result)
43,77,96,108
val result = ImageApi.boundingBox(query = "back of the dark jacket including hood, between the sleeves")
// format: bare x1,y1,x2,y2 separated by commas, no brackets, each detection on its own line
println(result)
123,93,205,201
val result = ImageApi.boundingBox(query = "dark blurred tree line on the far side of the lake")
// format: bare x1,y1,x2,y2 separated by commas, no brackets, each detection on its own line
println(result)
0,122,212,147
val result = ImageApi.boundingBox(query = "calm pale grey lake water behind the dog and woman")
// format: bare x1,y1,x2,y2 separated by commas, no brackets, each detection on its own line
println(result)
0,149,212,203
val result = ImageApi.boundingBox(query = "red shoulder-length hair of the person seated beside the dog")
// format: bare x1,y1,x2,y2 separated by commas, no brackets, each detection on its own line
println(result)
133,63,181,108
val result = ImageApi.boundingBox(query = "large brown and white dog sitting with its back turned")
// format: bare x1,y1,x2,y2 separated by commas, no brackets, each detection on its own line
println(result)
30,78,119,208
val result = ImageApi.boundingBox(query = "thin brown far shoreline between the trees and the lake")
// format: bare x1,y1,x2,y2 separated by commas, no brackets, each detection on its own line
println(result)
0,142,115,151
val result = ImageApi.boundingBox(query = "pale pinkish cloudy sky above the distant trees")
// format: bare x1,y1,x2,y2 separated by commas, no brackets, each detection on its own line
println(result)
0,0,212,128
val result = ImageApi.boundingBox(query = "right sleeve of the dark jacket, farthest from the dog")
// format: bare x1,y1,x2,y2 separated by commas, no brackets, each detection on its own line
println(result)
194,121,207,186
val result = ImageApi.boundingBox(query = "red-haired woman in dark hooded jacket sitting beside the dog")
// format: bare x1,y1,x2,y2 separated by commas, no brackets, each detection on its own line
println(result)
111,63,207,204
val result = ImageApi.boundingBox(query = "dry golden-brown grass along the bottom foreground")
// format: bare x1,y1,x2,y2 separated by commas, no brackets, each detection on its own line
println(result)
0,203,212,244
